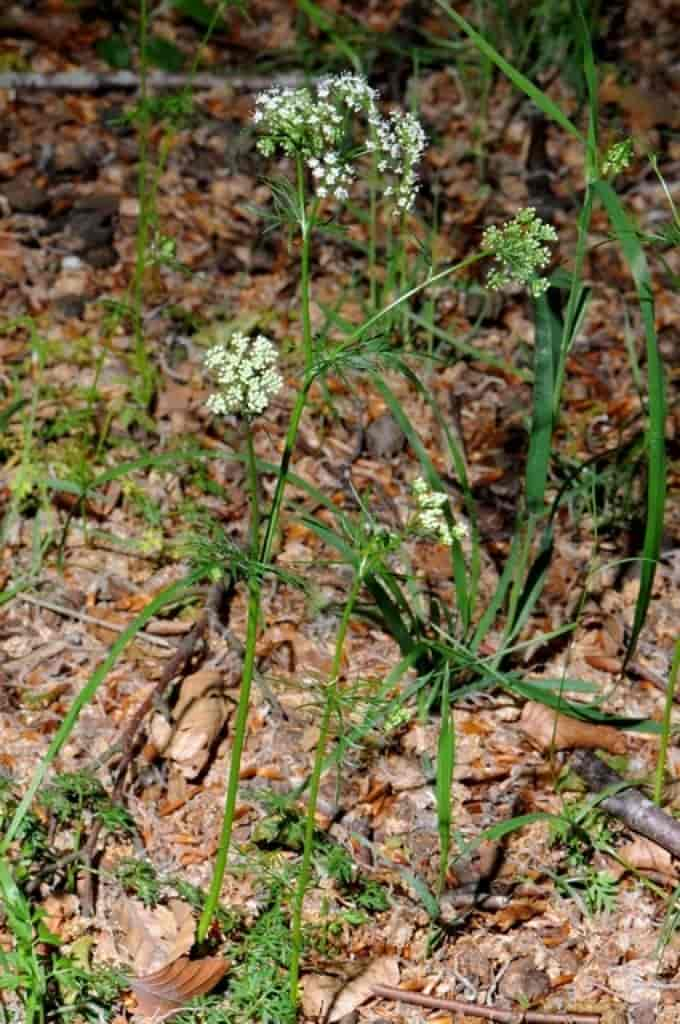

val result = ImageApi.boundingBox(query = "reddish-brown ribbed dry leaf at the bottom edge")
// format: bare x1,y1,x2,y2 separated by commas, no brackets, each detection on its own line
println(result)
130,956,229,1021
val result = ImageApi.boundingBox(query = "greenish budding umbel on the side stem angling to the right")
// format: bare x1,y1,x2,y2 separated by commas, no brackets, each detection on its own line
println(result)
481,206,557,296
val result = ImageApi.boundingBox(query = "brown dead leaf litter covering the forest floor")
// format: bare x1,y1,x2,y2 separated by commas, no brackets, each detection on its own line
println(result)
0,4,680,1022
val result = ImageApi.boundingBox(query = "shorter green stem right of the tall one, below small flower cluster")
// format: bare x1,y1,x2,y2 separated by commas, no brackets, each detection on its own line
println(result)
289,560,364,1008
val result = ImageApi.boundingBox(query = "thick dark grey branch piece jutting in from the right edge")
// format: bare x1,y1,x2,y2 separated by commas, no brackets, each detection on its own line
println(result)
569,751,680,857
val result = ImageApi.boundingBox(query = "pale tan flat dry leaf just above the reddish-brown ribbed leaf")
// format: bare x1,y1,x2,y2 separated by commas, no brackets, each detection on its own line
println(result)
116,898,196,974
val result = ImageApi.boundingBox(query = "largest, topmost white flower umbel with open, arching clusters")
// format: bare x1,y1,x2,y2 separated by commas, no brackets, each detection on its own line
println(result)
253,72,425,213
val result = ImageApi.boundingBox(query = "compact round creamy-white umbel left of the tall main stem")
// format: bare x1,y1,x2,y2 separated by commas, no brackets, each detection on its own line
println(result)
205,331,284,417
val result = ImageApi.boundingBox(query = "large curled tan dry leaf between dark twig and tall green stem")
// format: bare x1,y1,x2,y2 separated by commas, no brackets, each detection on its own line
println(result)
151,669,227,778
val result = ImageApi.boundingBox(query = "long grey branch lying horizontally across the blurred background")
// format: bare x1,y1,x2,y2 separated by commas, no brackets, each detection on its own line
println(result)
0,71,303,92
